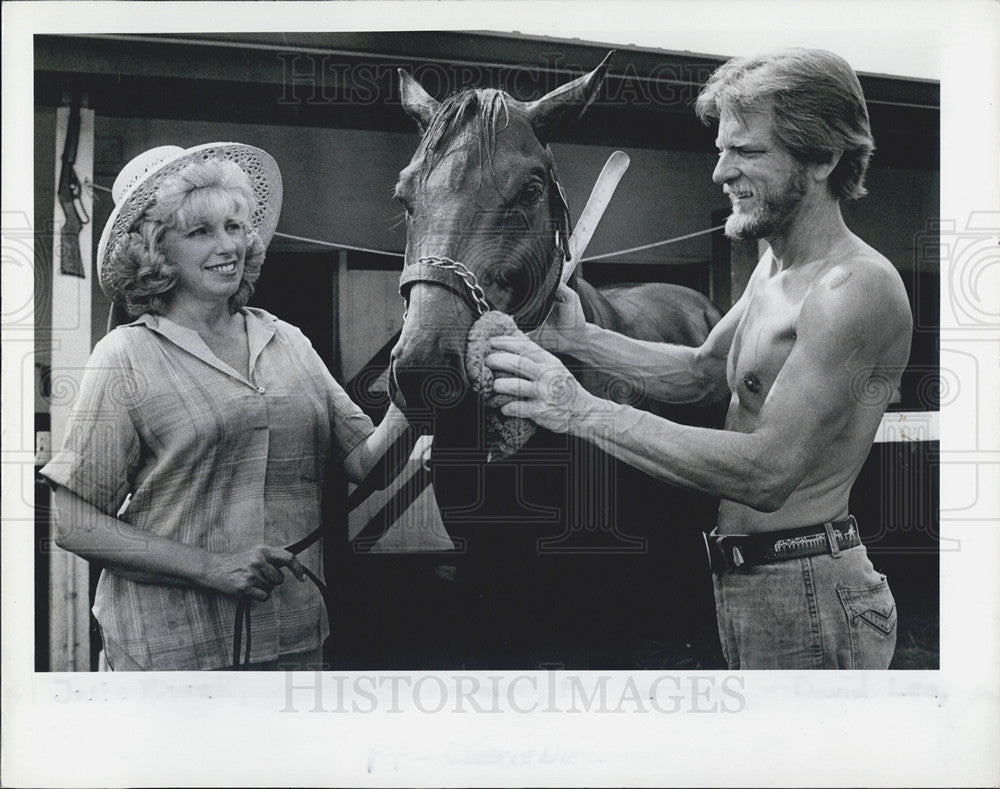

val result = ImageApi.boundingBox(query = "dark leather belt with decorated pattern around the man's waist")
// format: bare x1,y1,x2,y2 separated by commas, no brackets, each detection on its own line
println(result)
705,515,861,574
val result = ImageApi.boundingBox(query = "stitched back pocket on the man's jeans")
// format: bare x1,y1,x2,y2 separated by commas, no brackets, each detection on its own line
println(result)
837,575,896,669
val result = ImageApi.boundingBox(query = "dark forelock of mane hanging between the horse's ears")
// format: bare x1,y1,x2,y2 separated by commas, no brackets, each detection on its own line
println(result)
417,88,510,180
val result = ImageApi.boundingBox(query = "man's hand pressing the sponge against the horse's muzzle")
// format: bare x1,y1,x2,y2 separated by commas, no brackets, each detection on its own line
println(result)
486,330,597,433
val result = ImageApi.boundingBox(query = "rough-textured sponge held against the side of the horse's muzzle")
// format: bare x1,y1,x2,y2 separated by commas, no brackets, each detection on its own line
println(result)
465,310,535,462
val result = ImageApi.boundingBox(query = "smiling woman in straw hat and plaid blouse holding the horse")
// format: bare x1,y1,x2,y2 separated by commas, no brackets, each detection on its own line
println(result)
42,143,405,670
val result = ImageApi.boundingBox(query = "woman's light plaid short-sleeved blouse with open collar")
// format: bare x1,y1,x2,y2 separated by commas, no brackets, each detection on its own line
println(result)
42,308,374,670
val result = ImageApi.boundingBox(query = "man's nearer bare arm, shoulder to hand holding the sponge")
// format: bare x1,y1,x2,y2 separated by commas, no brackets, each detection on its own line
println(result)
491,268,909,511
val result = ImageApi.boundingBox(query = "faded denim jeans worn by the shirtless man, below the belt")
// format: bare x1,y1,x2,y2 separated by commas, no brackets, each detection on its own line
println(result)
713,545,896,669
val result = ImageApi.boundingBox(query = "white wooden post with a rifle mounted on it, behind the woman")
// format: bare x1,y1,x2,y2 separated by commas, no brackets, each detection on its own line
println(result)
49,107,94,671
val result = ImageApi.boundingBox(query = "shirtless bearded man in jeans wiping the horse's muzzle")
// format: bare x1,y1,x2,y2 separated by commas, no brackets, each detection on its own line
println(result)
487,50,912,669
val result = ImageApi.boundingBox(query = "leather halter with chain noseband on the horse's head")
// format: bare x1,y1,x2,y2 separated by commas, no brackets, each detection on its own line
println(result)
399,170,569,331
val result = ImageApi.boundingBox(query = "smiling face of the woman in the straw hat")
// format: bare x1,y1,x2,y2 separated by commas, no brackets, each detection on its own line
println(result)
160,192,247,310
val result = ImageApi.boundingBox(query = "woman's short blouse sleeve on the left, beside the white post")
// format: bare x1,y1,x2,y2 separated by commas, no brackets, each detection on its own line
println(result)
40,329,140,515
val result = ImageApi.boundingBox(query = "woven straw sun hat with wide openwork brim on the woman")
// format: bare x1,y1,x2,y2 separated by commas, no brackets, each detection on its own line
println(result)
97,142,281,301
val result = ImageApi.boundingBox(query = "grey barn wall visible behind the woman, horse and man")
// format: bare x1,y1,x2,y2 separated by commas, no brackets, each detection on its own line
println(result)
35,108,939,374
